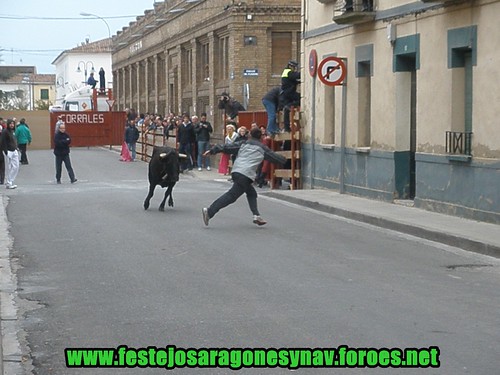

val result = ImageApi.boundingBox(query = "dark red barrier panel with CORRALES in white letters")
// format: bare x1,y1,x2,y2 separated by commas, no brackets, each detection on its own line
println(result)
50,111,127,148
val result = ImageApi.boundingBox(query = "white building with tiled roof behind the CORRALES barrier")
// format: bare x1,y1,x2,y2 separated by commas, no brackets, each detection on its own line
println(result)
52,38,113,105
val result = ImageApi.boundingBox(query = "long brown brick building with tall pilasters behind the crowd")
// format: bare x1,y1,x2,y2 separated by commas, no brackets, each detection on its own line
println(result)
113,0,300,138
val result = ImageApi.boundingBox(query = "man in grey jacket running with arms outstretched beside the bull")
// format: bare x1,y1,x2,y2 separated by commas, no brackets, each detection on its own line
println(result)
202,128,286,225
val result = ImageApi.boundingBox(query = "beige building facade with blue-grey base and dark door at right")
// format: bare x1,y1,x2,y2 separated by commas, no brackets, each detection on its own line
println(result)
302,0,500,223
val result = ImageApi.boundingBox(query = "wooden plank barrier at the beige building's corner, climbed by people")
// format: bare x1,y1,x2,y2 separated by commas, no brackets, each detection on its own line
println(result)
271,107,302,190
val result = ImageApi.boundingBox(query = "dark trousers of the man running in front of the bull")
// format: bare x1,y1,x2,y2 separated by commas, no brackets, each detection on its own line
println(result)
208,172,260,218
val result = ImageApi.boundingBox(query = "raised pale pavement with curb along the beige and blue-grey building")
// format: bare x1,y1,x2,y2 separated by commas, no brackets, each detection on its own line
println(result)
192,169,500,258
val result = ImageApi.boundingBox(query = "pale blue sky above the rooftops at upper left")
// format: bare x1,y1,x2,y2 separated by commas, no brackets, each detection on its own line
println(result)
0,0,159,74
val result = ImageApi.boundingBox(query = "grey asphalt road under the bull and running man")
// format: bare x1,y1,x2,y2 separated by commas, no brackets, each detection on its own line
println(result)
5,149,500,375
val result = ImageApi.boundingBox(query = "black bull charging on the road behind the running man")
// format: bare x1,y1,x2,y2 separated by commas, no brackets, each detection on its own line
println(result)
144,146,186,211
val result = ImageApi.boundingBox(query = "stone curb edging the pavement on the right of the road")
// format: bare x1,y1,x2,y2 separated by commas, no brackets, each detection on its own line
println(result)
264,191,500,258
